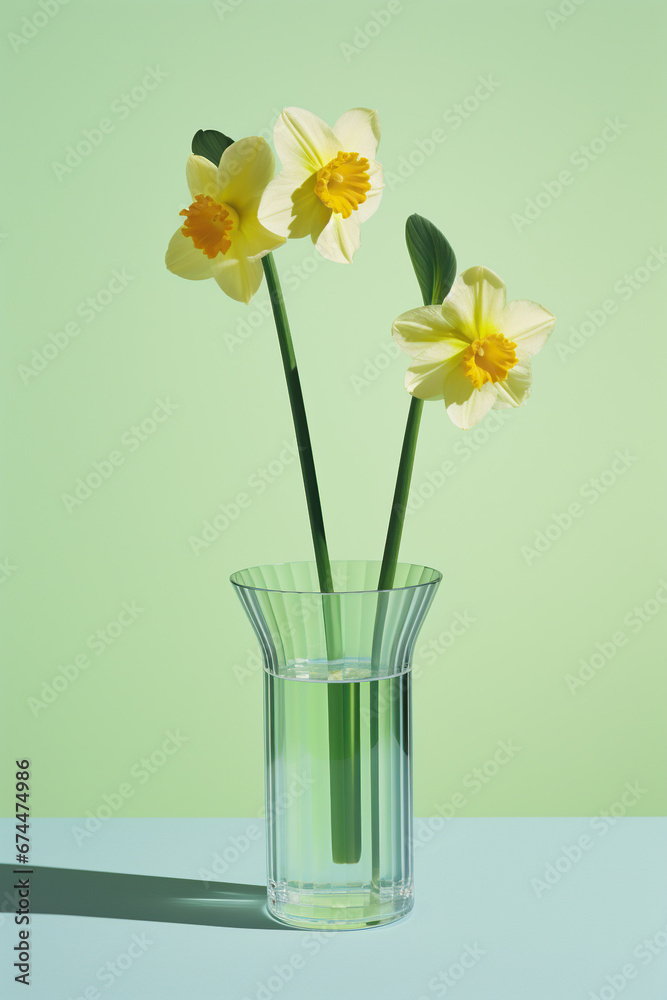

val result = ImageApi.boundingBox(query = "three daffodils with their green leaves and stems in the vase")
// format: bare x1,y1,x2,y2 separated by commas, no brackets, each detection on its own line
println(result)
166,108,555,863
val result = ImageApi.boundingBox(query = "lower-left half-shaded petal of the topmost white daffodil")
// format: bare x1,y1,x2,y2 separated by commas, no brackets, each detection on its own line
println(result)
258,170,331,239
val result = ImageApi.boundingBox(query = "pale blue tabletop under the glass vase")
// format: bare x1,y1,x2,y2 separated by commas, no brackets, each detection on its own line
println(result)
0,818,667,1000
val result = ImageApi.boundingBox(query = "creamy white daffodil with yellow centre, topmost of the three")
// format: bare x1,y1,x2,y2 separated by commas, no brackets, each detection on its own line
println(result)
259,108,383,263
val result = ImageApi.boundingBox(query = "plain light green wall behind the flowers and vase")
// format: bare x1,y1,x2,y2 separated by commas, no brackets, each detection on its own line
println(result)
0,0,667,816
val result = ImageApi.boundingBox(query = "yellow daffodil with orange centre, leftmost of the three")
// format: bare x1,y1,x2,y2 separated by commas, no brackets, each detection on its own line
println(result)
165,136,285,303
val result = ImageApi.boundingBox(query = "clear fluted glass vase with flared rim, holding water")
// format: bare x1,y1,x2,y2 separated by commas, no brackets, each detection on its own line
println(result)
231,561,441,929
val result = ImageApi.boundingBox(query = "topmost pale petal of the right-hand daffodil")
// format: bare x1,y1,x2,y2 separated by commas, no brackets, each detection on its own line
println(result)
442,267,507,341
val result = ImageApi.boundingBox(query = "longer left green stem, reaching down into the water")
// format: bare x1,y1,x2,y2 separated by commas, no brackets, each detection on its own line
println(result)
262,253,361,864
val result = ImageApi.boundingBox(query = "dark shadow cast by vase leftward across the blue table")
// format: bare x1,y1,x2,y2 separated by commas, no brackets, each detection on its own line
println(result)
0,865,291,931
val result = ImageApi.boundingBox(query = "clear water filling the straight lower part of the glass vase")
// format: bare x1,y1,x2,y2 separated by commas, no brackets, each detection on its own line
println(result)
264,670,413,929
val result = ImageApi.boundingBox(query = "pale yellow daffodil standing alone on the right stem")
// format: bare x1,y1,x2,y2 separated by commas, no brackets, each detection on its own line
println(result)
392,267,556,429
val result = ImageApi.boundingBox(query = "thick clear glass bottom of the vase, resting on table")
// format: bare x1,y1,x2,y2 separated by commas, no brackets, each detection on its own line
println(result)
268,884,414,931
